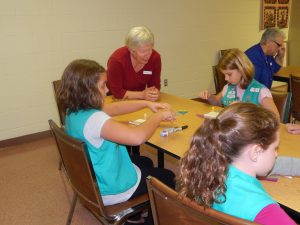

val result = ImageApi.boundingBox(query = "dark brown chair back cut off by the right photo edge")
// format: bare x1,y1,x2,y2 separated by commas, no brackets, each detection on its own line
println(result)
290,74,300,121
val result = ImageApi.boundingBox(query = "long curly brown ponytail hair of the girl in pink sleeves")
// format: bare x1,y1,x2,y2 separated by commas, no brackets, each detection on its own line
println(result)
177,103,279,207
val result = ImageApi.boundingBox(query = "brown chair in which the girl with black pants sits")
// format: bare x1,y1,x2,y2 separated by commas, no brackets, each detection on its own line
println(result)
49,120,149,225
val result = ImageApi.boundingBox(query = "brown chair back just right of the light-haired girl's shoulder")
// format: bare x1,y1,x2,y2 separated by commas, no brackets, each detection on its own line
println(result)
271,90,292,123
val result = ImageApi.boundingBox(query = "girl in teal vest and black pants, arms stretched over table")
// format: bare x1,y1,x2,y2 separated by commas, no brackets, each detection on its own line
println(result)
57,59,175,223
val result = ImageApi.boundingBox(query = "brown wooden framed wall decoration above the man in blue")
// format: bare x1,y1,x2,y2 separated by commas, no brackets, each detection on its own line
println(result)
262,0,292,29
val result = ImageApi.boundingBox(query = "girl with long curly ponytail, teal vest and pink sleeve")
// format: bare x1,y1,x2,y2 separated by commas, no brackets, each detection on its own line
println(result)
177,103,296,225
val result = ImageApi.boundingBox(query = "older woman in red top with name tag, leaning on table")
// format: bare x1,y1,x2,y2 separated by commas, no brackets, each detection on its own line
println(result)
107,26,161,101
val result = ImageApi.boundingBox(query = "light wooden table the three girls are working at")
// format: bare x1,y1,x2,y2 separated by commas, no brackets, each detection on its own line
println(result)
108,93,300,212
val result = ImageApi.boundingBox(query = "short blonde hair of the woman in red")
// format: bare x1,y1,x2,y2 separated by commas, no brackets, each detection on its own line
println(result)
125,26,154,49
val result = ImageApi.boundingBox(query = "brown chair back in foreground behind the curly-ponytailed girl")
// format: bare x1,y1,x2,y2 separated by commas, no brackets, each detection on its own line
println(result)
147,177,256,225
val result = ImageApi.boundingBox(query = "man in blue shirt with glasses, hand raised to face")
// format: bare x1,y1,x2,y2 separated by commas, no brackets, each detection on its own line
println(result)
245,28,285,88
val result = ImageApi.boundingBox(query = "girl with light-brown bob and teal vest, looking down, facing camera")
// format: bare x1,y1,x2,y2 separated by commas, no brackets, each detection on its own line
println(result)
199,49,279,117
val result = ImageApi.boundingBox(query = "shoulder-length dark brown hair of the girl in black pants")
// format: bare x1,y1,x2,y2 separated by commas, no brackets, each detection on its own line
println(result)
57,59,105,115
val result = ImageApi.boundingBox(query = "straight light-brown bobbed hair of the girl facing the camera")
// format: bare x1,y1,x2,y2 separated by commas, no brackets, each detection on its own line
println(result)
217,48,254,89
